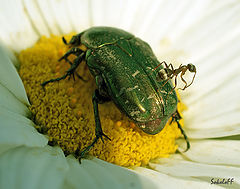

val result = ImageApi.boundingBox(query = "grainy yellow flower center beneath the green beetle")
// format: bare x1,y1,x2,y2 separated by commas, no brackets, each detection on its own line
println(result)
19,35,185,166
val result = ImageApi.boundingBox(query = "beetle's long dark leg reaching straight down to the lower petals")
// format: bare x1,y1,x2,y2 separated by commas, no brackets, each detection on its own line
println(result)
79,89,111,163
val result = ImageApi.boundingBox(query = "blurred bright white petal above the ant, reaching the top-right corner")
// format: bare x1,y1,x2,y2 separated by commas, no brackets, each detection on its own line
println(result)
175,1,240,60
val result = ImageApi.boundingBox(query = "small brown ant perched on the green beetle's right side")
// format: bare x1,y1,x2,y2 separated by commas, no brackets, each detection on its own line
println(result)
154,61,197,93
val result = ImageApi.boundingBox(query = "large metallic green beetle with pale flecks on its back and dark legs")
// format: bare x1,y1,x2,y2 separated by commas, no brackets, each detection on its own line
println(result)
41,27,190,160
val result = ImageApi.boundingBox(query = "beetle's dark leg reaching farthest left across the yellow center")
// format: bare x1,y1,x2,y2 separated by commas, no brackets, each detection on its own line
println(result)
41,52,85,87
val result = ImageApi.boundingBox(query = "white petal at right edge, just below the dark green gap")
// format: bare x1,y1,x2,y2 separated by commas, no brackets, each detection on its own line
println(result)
179,140,240,166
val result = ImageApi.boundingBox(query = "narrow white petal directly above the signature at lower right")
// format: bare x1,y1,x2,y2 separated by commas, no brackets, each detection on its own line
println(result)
149,156,240,187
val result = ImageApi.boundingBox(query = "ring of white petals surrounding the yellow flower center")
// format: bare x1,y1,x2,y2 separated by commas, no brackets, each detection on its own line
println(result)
0,0,240,189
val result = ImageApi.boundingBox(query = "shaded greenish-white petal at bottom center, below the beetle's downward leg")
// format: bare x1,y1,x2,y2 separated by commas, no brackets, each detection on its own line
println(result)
65,156,156,189
